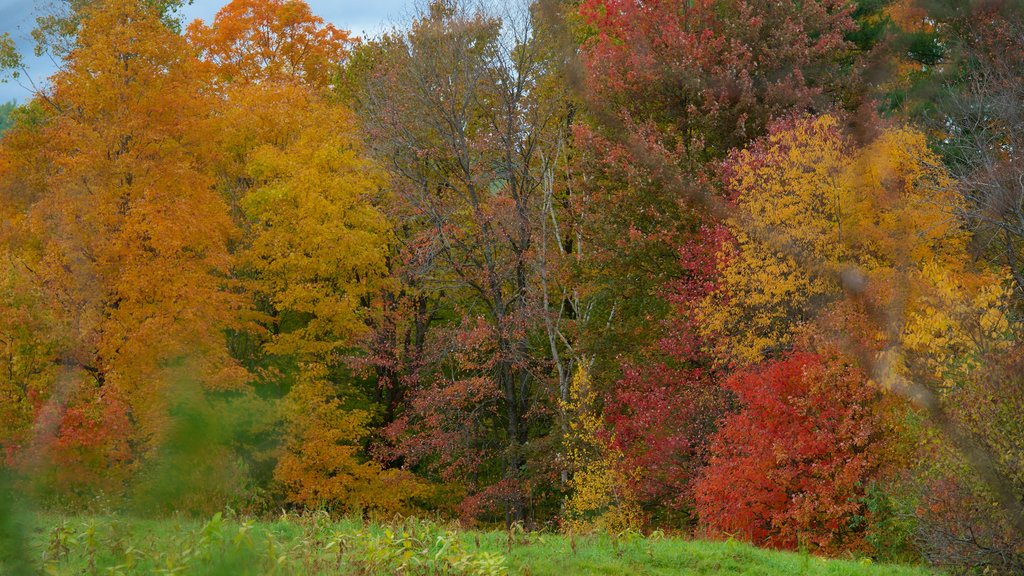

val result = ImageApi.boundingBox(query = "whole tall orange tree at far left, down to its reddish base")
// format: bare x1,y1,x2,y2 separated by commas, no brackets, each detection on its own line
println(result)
5,1,248,496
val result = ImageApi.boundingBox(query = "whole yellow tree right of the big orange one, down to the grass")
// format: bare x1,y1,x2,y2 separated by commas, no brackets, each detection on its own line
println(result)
241,91,417,510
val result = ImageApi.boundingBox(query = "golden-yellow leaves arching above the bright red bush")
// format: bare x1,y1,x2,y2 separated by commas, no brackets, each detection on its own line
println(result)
698,116,1006,378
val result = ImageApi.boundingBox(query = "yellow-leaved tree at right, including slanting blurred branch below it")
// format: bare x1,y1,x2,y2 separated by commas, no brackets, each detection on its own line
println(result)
698,112,1019,541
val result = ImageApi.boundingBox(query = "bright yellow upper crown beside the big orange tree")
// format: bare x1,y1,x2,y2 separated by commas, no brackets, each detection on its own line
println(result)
240,87,390,355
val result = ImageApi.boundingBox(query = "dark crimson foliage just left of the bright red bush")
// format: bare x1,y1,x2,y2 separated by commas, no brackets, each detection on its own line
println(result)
605,227,733,526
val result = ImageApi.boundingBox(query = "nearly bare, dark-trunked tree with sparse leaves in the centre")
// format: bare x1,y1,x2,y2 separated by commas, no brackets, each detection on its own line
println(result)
362,2,563,522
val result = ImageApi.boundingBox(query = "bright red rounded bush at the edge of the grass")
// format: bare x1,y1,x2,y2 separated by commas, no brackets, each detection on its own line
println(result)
695,353,886,551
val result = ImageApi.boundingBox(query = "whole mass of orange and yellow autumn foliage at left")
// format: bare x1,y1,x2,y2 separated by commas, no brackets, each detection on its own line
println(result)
3,1,403,508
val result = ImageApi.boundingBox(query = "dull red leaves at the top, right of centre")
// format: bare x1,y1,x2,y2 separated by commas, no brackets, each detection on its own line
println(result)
580,0,854,152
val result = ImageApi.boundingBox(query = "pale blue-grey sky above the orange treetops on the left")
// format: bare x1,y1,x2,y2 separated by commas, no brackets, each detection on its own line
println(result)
0,0,413,102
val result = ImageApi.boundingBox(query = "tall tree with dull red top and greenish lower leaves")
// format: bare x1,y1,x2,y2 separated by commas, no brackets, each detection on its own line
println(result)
577,0,856,374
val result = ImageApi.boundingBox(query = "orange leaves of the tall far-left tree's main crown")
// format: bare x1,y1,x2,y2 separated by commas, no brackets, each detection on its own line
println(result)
40,2,248,398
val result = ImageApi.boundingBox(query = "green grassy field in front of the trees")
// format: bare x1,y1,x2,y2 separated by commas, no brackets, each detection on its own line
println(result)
0,515,931,576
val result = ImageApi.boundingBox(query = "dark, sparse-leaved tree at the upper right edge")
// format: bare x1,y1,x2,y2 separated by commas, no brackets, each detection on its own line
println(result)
928,2,1024,301
